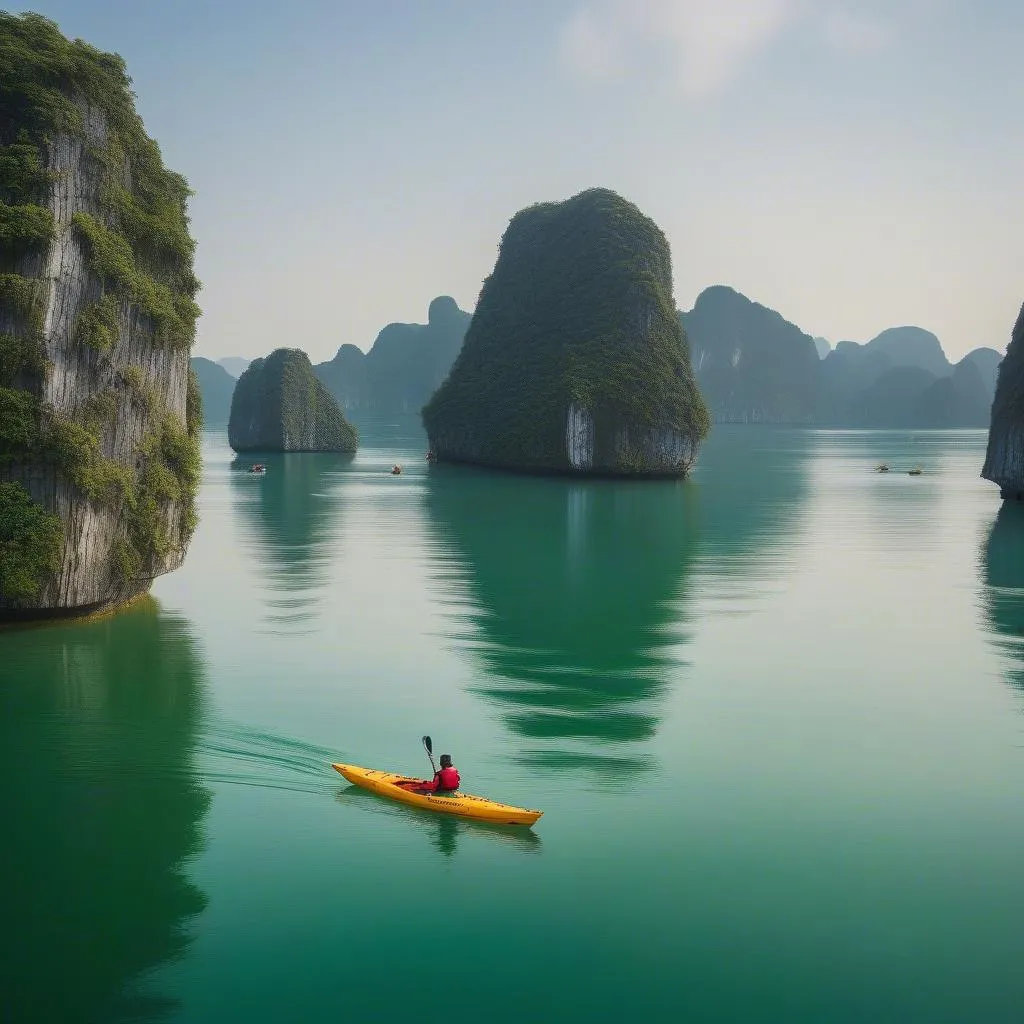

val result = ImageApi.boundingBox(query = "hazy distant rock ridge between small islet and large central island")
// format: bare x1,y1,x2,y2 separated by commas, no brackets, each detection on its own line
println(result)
313,295,470,414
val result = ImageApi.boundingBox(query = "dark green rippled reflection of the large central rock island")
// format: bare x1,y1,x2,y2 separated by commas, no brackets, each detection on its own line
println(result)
426,466,696,777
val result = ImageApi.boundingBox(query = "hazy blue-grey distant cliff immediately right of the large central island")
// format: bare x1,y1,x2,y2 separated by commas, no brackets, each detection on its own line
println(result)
682,286,820,423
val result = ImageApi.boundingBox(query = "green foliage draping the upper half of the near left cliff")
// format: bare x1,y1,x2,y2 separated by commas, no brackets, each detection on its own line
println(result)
0,13,199,347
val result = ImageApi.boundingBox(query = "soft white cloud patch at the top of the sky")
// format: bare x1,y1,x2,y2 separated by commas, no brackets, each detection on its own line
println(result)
562,0,890,100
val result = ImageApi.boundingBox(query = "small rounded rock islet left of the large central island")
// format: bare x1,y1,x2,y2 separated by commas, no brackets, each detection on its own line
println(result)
227,348,358,452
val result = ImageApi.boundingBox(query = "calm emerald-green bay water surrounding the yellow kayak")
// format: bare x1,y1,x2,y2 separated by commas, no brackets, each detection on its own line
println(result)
0,421,1024,1024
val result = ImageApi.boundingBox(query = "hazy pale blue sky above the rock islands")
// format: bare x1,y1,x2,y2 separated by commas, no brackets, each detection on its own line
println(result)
16,0,1024,361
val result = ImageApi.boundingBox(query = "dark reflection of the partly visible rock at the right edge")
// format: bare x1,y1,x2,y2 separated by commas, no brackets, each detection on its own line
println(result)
984,502,1024,688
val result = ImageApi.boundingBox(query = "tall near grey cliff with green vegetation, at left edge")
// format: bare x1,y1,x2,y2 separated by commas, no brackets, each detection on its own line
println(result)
0,13,202,617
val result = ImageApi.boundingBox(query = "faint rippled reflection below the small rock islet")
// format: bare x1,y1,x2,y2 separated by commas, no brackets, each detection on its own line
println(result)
230,452,352,632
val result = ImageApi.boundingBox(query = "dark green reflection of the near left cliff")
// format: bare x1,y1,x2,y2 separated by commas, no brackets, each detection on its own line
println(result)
0,600,209,1024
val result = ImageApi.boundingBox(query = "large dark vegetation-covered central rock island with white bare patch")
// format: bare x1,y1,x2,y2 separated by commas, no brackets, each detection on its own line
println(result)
423,188,710,475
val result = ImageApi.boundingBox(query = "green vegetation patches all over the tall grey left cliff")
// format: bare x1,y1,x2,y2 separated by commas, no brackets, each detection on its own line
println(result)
0,12,201,597
